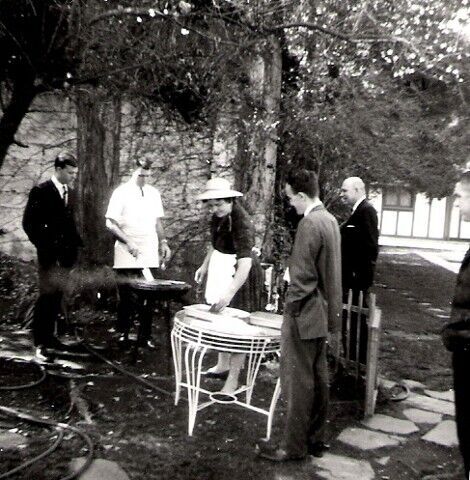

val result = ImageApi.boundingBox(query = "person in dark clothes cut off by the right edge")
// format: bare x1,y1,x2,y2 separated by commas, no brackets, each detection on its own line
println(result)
442,172,470,479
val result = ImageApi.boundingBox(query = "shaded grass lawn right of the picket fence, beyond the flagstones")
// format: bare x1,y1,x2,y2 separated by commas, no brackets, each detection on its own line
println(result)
373,249,456,389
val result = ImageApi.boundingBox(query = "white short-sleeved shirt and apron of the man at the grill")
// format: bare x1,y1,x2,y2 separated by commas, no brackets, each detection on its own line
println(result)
106,179,164,268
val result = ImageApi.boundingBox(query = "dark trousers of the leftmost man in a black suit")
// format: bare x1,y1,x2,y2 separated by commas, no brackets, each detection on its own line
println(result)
31,266,70,347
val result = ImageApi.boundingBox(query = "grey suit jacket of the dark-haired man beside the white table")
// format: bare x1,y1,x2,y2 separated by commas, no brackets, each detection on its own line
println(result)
284,205,342,340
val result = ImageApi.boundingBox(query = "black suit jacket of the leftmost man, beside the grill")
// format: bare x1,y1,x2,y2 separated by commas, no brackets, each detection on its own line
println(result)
23,180,82,268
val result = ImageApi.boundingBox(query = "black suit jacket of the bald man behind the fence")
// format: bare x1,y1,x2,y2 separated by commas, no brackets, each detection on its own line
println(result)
341,200,379,293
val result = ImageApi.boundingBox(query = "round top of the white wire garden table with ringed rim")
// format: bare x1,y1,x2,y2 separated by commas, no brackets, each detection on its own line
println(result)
173,310,281,353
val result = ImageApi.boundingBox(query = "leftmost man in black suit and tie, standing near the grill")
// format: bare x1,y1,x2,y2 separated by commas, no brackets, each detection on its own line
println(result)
23,152,82,360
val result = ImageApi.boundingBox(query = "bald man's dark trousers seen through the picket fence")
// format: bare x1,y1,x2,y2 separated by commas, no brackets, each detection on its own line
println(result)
342,290,369,365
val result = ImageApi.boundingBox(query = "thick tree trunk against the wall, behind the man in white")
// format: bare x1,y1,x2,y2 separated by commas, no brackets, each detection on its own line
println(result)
77,91,121,266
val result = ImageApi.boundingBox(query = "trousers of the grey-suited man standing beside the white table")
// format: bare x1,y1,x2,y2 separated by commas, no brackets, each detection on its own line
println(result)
281,315,329,457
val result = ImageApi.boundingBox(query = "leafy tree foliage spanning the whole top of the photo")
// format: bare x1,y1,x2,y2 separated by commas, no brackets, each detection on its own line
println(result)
0,0,470,197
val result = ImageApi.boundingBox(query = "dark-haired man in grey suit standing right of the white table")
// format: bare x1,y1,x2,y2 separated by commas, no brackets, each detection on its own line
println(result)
257,170,341,462
